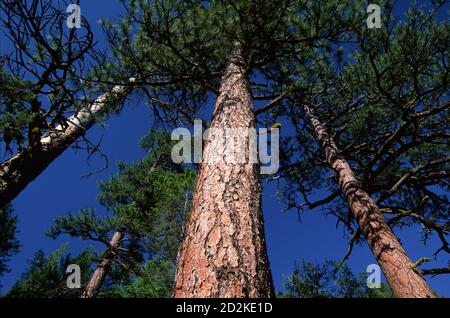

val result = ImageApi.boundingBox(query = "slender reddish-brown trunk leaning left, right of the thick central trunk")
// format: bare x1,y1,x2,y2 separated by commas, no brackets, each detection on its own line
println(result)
303,104,435,298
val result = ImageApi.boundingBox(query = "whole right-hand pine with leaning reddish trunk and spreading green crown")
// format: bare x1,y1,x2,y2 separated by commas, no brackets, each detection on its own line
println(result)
274,3,449,297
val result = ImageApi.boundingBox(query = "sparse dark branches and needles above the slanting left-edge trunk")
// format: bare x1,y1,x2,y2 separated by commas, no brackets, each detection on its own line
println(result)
0,0,121,155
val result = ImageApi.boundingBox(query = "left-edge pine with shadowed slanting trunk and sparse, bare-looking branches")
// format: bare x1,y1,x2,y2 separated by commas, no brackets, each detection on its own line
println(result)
0,0,142,207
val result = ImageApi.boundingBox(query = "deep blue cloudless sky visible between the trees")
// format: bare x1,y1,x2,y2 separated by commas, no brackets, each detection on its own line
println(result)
0,0,450,297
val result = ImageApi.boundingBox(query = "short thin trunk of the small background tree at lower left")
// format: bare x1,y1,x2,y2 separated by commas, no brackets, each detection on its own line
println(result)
80,231,123,298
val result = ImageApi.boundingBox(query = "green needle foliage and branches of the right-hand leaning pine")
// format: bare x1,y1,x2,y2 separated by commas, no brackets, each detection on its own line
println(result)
279,1,450,255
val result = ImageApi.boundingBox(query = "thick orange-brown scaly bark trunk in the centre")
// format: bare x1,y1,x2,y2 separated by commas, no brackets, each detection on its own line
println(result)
174,48,273,297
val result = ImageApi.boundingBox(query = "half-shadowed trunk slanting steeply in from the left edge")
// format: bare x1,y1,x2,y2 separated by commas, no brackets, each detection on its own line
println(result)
0,78,134,207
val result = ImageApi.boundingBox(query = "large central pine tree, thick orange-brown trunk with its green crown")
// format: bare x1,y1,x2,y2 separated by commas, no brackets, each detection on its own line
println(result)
108,0,362,297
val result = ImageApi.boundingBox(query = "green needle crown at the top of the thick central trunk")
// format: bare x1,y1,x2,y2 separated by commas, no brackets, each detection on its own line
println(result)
99,0,364,123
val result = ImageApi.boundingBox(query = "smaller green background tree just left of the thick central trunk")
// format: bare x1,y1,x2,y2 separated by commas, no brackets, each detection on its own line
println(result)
48,131,195,298
